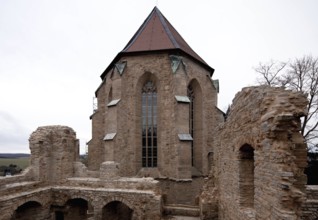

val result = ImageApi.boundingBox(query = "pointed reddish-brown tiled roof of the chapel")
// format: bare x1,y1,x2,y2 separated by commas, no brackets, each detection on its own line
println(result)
101,7,214,79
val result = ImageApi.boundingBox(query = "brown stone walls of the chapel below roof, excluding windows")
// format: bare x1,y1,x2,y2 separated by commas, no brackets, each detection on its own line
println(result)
88,54,221,179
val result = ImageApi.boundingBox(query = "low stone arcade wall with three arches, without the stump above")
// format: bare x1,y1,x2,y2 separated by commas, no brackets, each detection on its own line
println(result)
0,186,161,220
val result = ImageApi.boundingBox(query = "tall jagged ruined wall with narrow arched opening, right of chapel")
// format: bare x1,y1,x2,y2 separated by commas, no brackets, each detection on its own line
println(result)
212,87,307,220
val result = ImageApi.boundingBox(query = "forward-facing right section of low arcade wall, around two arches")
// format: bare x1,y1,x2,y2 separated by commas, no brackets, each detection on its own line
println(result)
52,187,161,220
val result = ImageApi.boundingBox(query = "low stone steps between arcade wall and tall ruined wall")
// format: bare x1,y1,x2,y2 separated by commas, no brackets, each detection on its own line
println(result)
163,204,200,220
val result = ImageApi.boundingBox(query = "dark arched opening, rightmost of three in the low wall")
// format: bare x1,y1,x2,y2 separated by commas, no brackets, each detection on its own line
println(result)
102,201,133,220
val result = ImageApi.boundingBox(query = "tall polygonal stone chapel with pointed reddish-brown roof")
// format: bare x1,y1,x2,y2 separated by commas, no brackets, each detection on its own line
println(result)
88,8,224,199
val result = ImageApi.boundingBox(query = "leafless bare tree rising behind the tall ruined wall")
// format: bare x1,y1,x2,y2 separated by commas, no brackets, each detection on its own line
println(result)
254,56,318,148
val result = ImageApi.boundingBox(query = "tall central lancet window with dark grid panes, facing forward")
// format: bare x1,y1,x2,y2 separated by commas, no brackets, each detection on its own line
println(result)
141,81,158,167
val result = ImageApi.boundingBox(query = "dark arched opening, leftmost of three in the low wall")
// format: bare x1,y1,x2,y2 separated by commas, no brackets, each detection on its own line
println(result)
11,201,45,220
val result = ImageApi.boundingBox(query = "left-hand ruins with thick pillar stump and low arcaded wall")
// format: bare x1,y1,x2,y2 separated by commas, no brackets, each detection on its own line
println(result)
0,126,162,220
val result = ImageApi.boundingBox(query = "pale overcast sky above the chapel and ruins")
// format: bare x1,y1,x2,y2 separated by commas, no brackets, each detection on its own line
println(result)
0,0,318,153
